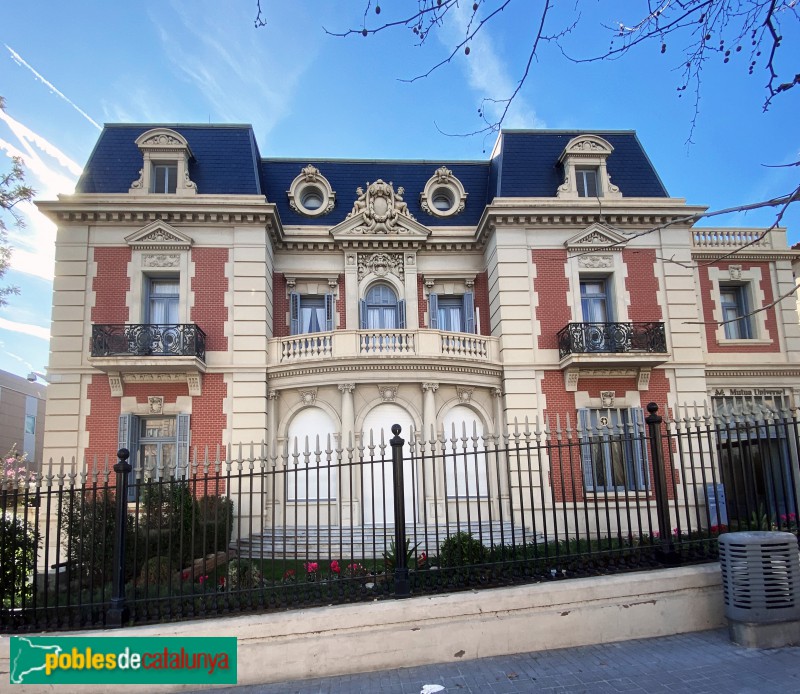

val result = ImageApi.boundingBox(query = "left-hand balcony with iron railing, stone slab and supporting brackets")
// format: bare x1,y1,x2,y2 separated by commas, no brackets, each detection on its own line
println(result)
89,323,206,395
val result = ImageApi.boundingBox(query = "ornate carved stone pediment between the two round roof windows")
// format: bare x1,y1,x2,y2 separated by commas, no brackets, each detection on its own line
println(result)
331,179,430,247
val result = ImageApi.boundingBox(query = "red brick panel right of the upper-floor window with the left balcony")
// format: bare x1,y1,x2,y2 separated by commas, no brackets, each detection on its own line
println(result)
189,248,228,352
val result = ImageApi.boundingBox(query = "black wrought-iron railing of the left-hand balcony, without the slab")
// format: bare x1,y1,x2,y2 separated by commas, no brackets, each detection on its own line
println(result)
92,323,206,361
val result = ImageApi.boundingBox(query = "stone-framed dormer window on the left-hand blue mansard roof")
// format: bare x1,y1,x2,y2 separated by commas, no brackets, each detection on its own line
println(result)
128,128,197,196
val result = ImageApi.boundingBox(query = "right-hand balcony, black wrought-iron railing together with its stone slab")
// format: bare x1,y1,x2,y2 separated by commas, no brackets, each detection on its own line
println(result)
558,322,669,368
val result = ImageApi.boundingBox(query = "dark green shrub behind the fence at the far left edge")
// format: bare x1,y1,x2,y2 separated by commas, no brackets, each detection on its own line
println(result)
0,514,40,607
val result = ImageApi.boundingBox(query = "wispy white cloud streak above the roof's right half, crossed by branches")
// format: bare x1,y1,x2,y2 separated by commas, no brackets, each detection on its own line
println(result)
438,3,544,128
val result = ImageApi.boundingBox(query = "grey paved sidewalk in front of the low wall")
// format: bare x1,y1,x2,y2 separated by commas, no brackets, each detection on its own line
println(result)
208,629,800,694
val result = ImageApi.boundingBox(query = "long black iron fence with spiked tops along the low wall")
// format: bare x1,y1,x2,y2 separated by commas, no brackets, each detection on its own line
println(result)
0,405,800,632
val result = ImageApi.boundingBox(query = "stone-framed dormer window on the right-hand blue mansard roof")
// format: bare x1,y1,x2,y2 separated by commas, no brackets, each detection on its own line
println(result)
556,134,622,199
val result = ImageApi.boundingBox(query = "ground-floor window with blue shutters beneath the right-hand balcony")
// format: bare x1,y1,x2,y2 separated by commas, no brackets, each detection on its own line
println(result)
578,407,650,493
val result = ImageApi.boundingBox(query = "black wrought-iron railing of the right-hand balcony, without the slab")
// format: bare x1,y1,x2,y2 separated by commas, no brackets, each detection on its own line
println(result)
558,323,667,359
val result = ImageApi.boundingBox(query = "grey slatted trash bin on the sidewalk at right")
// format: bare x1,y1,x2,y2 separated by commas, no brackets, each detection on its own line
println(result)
719,531,800,648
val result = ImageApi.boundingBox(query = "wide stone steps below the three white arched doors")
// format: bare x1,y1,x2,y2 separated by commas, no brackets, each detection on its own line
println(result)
231,521,544,559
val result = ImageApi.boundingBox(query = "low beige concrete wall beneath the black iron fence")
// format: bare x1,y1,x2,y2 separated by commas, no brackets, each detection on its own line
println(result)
0,564,725,694
